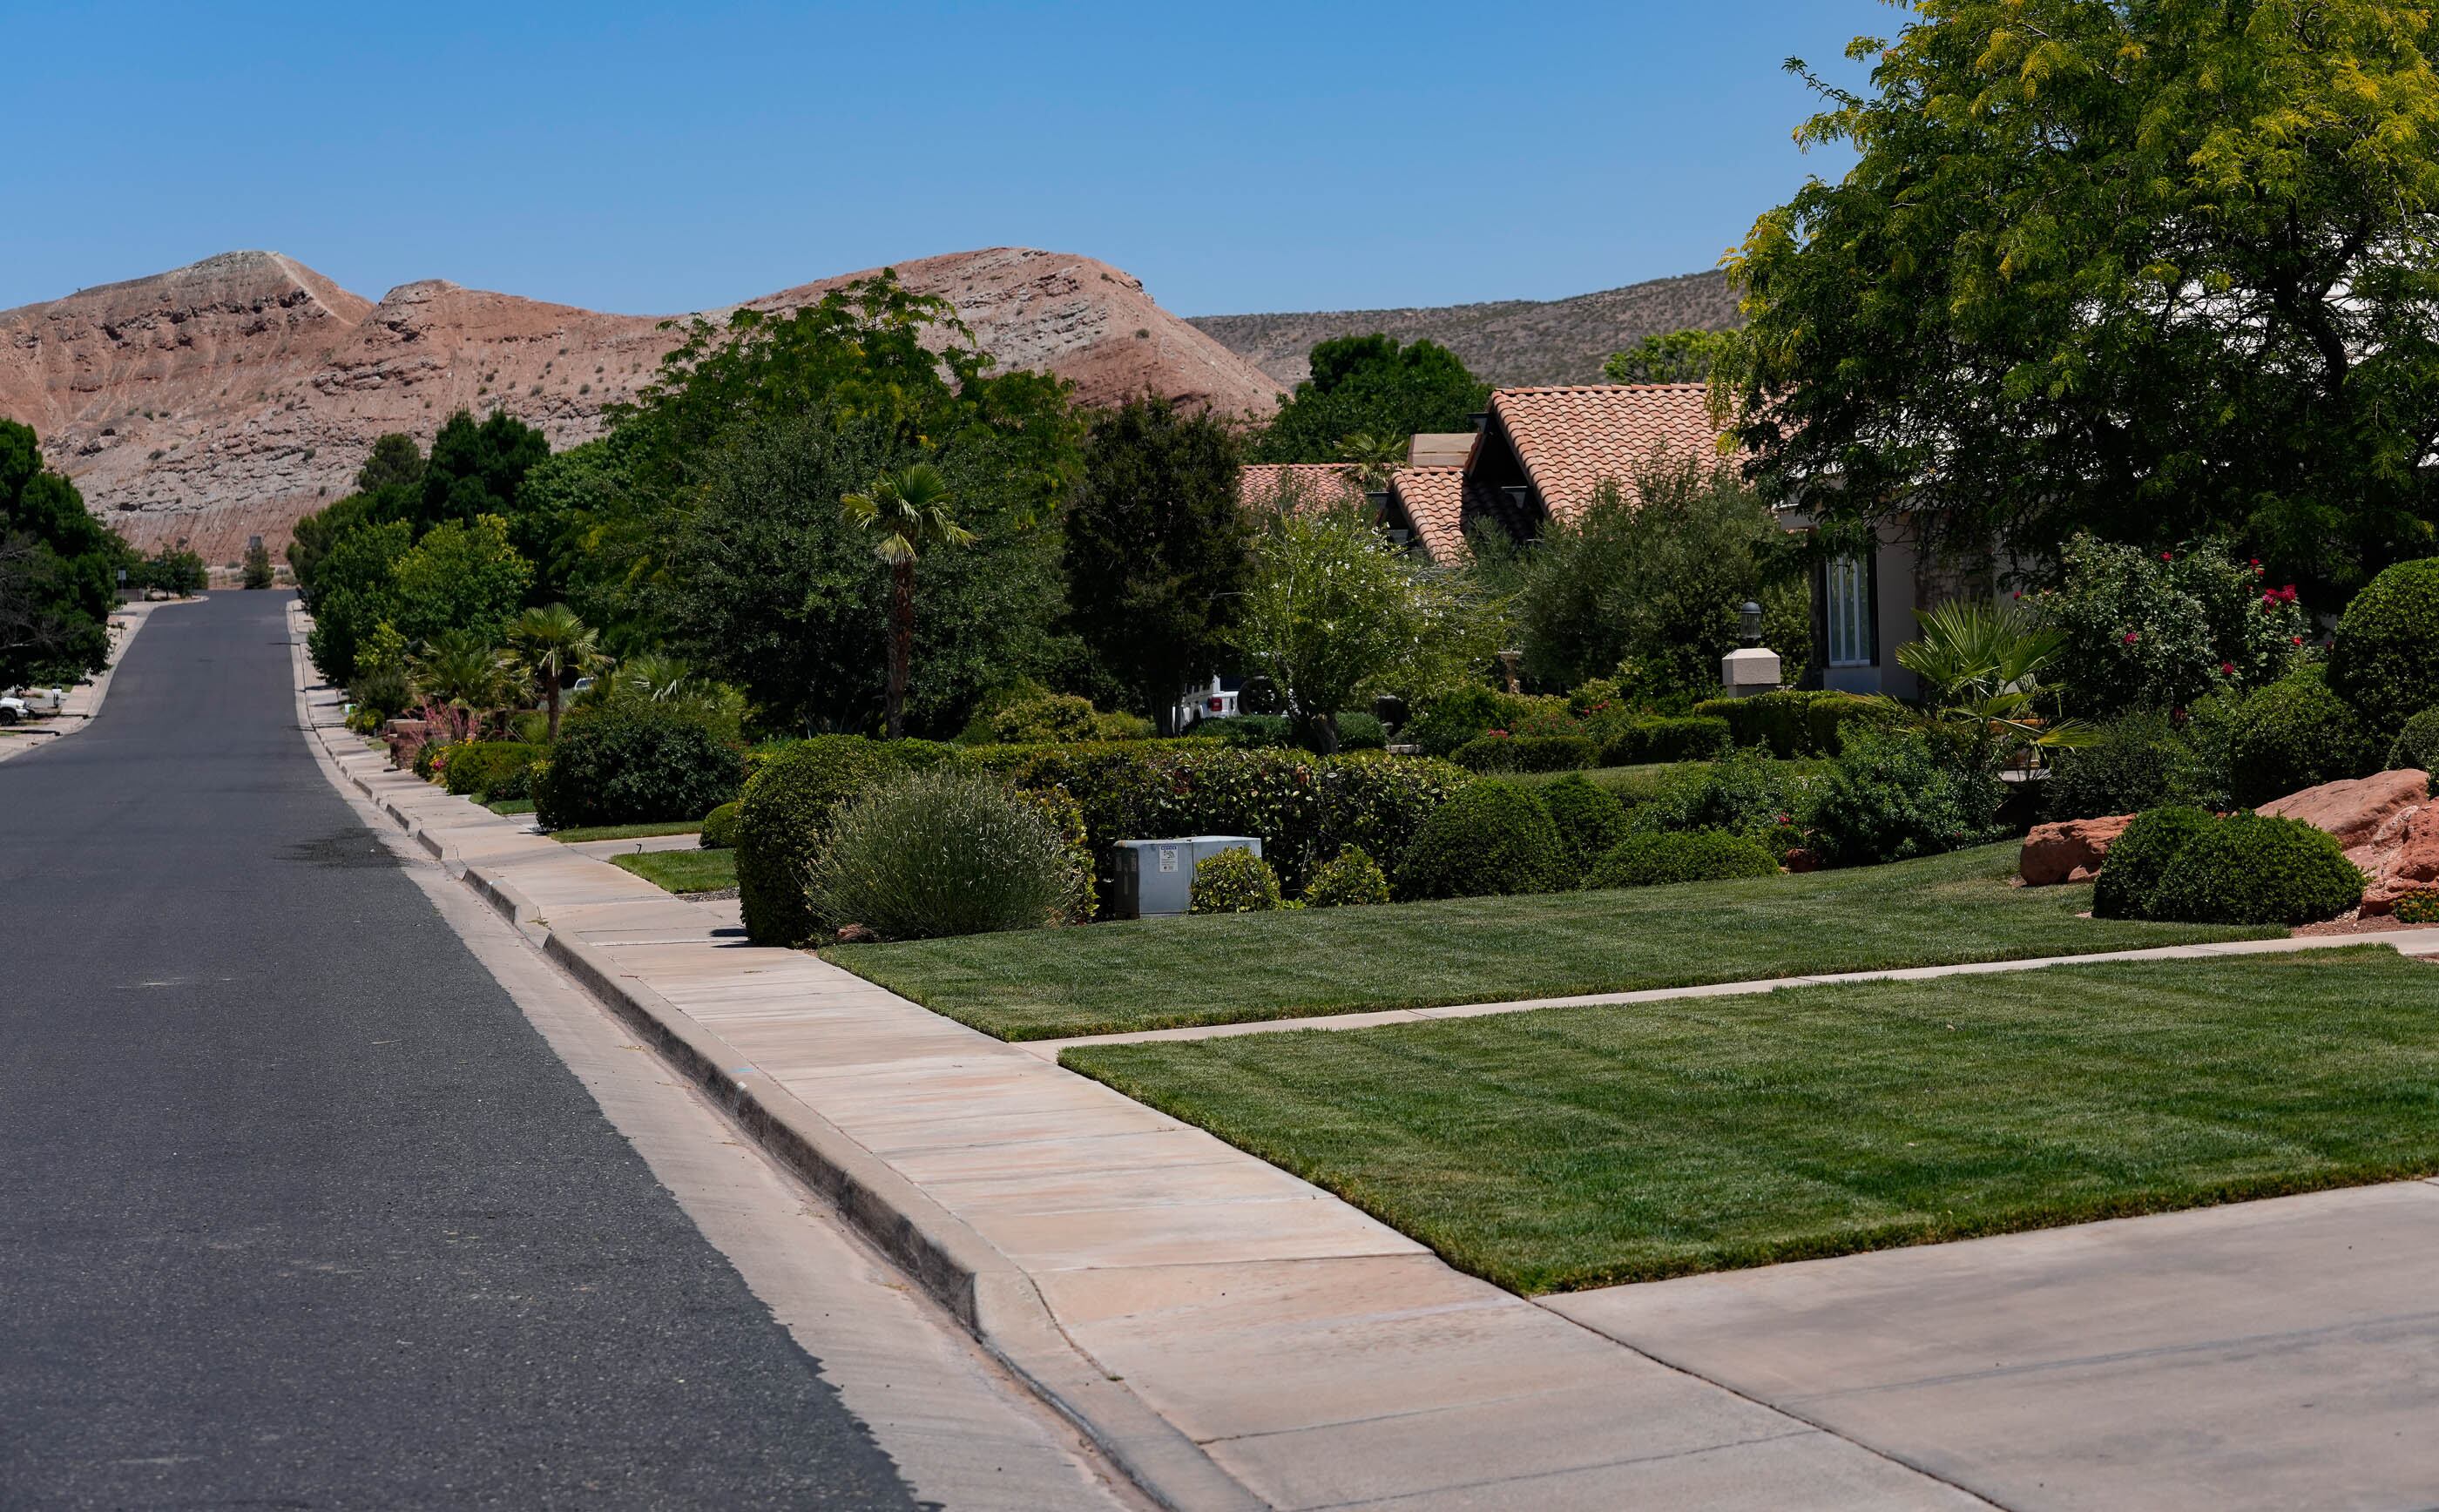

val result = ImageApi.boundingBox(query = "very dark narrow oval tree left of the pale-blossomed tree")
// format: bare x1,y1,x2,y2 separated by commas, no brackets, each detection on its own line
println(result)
1064,397,1253,734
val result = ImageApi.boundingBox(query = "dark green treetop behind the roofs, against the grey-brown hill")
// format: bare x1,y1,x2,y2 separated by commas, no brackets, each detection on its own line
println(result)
1251,334,1490,461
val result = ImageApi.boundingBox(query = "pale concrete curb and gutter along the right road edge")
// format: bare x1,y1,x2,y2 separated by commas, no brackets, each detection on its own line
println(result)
293,615,1268,1512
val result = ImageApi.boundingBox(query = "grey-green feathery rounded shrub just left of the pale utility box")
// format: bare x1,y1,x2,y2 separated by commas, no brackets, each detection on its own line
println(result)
805,761,1076,939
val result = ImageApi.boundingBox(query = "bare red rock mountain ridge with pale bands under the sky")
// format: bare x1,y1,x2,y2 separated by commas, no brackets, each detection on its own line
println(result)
0,246,1280,564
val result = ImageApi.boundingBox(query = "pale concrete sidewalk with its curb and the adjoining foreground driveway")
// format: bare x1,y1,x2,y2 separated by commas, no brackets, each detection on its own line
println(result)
300,604,2439,1509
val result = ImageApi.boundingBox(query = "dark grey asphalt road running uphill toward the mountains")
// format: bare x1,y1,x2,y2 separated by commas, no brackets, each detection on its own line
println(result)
0,592,912,1507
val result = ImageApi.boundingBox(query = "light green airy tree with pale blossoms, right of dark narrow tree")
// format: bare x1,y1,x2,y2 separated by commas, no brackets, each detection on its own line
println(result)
1232,492,1463,753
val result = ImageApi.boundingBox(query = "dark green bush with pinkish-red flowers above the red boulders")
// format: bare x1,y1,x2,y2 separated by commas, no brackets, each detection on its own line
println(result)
2024,534,2312,714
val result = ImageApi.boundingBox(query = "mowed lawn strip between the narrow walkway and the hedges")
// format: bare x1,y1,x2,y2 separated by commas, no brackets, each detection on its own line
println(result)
822,844,2283,1039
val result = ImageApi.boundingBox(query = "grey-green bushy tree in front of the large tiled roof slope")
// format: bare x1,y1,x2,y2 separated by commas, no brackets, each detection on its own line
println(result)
1515,456,1810,702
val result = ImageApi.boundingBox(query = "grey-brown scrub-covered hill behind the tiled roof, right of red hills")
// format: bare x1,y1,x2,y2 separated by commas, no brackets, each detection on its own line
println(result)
1188,273,1741,388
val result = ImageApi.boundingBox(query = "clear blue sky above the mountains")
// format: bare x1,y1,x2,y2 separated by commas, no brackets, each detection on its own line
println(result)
0,0,1905,314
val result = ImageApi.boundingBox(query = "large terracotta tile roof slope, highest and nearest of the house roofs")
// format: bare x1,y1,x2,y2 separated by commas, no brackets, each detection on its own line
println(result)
1490,383,1719,519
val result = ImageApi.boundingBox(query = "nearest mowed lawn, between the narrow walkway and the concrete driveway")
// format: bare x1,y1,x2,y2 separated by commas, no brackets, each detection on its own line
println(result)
1061,946,2439,1293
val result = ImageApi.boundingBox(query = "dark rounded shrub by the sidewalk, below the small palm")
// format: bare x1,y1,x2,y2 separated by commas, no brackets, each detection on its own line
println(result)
534,702,744,829
